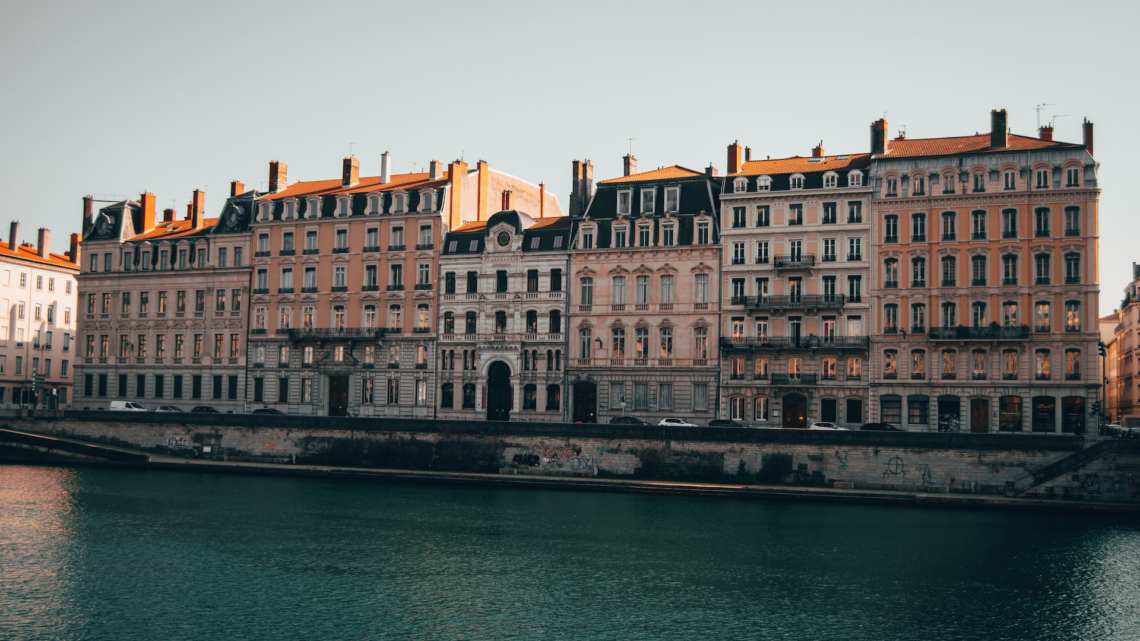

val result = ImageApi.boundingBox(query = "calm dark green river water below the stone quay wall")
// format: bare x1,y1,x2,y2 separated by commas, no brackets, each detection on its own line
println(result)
0,466,1140,641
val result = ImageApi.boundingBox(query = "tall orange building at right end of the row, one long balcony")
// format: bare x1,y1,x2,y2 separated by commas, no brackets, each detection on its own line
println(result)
870,111,1100,433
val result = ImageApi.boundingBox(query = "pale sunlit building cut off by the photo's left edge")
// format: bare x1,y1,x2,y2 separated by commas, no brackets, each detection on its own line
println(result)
0,221,80,409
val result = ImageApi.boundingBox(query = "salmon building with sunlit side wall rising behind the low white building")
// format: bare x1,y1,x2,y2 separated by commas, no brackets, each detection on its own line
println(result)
250,152,561,417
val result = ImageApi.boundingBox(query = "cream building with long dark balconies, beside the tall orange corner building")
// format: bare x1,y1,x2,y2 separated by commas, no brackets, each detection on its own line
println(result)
720,143,871,428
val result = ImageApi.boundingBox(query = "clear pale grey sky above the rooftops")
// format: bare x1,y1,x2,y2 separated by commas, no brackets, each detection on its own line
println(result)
0,0,1140,314
